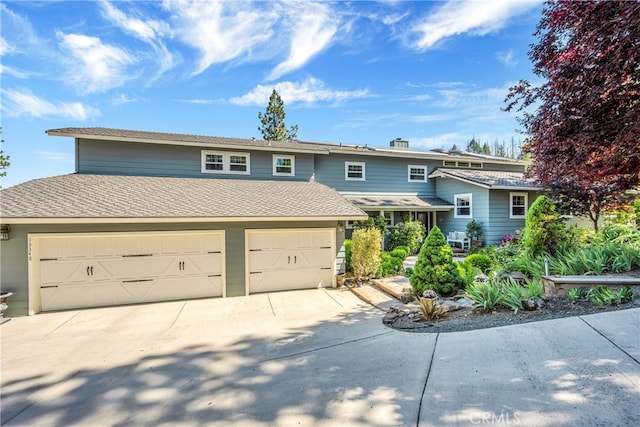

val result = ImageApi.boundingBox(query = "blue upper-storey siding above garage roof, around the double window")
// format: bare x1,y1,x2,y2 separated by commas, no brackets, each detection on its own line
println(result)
77,140,314,181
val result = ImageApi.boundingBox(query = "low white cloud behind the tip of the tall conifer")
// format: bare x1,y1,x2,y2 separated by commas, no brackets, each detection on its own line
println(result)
229,78,373,106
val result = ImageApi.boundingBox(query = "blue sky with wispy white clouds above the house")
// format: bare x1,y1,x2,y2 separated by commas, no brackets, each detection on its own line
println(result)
0,0,542,188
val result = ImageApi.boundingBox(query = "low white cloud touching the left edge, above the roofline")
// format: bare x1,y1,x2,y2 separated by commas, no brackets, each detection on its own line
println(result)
2,89,100,120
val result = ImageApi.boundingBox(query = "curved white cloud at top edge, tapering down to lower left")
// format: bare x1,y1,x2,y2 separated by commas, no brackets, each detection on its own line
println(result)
268,2,339,80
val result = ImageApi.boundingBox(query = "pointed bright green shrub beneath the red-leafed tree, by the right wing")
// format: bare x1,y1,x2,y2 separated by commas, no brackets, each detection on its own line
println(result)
522,196,567,255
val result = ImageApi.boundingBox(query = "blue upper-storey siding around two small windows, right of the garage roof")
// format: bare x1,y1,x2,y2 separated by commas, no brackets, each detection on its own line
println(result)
315,154,442,197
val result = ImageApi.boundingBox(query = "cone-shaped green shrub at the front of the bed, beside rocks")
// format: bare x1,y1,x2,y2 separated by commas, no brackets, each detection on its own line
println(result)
410,226,464,295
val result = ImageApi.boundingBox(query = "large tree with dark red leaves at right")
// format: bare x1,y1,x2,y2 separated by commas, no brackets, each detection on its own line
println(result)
505,0,640,230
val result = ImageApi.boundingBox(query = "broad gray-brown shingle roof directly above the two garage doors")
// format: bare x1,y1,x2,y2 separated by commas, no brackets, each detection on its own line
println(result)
0,174,366,223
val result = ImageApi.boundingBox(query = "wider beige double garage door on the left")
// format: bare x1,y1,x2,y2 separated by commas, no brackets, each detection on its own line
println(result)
37,231,225,311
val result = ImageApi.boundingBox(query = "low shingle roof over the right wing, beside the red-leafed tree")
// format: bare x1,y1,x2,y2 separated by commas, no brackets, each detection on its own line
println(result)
429,168,542,190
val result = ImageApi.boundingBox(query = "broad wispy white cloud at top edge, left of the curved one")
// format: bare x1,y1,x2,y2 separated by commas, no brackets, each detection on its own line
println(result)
163,0,278,75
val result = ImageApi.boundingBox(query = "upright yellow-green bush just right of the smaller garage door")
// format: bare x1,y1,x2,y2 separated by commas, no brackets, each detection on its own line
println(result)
351,228,382,280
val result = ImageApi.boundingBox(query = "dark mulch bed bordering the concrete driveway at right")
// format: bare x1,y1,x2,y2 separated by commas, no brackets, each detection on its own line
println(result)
383,286,640,333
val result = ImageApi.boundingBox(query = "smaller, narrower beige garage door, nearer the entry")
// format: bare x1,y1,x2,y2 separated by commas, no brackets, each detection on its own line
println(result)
245,228,335,293
